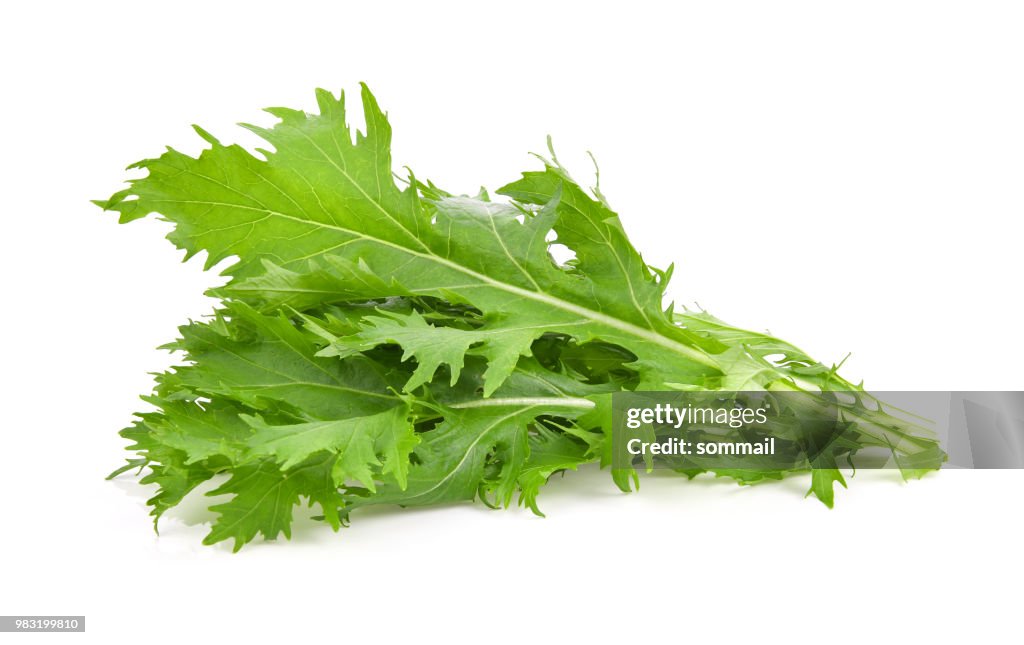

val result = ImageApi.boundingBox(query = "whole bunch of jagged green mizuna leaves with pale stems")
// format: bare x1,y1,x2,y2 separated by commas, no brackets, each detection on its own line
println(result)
97,87,943,550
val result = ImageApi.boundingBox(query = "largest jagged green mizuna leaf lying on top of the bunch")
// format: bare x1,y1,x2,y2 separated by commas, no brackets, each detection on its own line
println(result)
101,83,720,392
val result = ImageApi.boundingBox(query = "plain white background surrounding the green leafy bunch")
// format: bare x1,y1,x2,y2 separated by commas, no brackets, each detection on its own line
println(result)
0,0,1024,643
